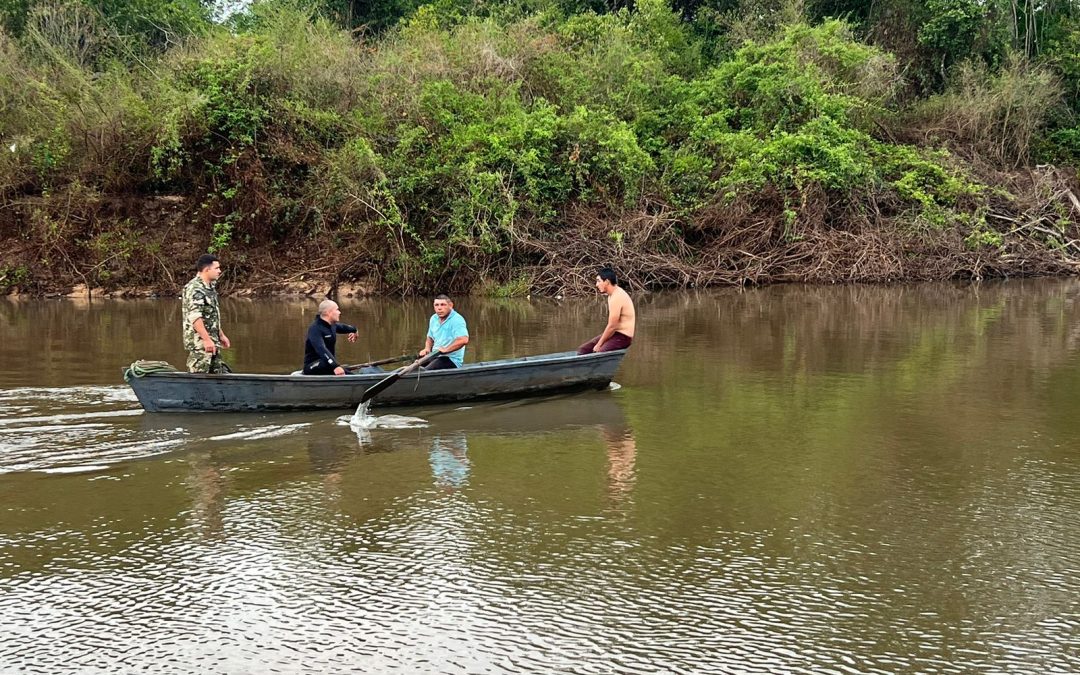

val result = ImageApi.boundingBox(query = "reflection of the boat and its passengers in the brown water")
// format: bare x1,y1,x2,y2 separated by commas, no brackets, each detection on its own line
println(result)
140,392,637,516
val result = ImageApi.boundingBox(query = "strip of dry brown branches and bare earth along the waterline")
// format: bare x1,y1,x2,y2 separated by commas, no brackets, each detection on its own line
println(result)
0,160,1080,297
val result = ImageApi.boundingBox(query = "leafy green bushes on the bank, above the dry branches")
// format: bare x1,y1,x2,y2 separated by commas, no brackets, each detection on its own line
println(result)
0,0,1080,288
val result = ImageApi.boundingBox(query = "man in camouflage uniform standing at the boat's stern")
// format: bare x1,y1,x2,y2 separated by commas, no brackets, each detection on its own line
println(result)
181,254,231,373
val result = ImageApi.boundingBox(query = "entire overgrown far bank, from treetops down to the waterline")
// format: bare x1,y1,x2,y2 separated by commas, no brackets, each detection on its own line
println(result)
0,0,1080,295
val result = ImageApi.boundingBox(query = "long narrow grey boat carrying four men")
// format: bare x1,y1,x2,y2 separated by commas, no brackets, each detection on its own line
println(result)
124,350,626,413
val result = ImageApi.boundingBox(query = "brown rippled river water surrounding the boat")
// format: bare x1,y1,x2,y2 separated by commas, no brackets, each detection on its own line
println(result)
0,280,1080,674
